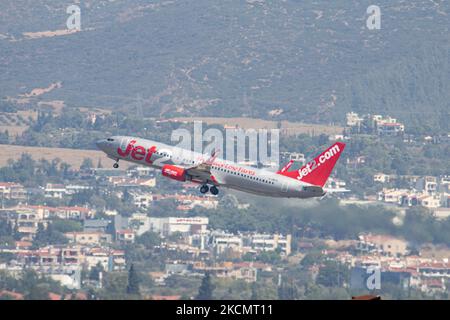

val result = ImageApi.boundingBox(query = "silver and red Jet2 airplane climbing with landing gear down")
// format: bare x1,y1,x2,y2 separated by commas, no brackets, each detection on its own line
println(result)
96,136,345,199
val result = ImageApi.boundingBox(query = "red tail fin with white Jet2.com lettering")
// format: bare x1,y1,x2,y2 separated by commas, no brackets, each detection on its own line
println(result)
278,142,345,187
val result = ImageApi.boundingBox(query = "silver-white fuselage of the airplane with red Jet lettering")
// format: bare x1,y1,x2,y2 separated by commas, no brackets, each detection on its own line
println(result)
97,136,324,198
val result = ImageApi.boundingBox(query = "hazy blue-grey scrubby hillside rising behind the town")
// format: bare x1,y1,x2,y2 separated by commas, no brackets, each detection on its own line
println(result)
0,0,450,130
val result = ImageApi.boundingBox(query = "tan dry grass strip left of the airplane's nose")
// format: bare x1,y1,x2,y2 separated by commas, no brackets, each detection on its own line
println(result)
0,144,132,169
